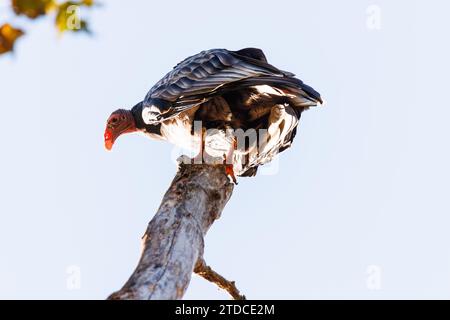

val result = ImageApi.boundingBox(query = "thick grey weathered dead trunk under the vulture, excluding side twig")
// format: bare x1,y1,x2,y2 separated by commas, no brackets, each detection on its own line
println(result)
108,157,233,300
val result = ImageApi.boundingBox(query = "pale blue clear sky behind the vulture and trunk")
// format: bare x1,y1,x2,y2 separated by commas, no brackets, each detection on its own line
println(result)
0,0,450,299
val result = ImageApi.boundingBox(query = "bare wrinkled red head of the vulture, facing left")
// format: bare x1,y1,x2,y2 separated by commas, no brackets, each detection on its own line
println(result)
105,109,136,150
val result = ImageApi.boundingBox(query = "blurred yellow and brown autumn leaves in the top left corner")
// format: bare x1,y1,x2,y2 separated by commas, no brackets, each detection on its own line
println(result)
0,0,96,55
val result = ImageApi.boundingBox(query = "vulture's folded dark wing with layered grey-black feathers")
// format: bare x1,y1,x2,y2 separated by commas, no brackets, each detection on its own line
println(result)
143,48,320,121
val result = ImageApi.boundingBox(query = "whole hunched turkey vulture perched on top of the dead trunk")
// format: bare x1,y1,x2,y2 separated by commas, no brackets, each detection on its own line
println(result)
104,48,322,181
